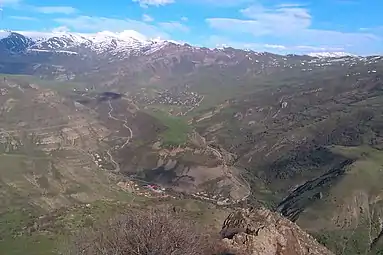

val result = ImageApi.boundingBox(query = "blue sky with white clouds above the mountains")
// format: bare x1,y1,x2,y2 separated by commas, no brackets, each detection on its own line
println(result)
0,0,383,55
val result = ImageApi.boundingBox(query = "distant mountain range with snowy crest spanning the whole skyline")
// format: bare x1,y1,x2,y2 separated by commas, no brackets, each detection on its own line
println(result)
0,31,381,93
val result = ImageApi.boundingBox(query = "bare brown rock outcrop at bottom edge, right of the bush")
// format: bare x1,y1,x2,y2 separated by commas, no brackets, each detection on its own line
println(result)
221,209,333,255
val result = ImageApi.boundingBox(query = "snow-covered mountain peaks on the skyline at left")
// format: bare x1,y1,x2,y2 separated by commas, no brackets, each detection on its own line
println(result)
0,31,169,55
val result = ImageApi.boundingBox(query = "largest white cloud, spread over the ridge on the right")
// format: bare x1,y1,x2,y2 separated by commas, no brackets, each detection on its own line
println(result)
206,4,379,54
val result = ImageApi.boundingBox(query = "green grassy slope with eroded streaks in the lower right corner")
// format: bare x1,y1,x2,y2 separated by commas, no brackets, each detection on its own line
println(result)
298,146,383,254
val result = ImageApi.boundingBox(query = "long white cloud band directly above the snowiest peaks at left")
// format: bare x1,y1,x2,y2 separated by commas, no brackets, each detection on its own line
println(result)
55,16,169,39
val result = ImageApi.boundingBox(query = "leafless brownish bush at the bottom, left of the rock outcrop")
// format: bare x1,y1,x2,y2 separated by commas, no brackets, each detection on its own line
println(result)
70,210,237,255
